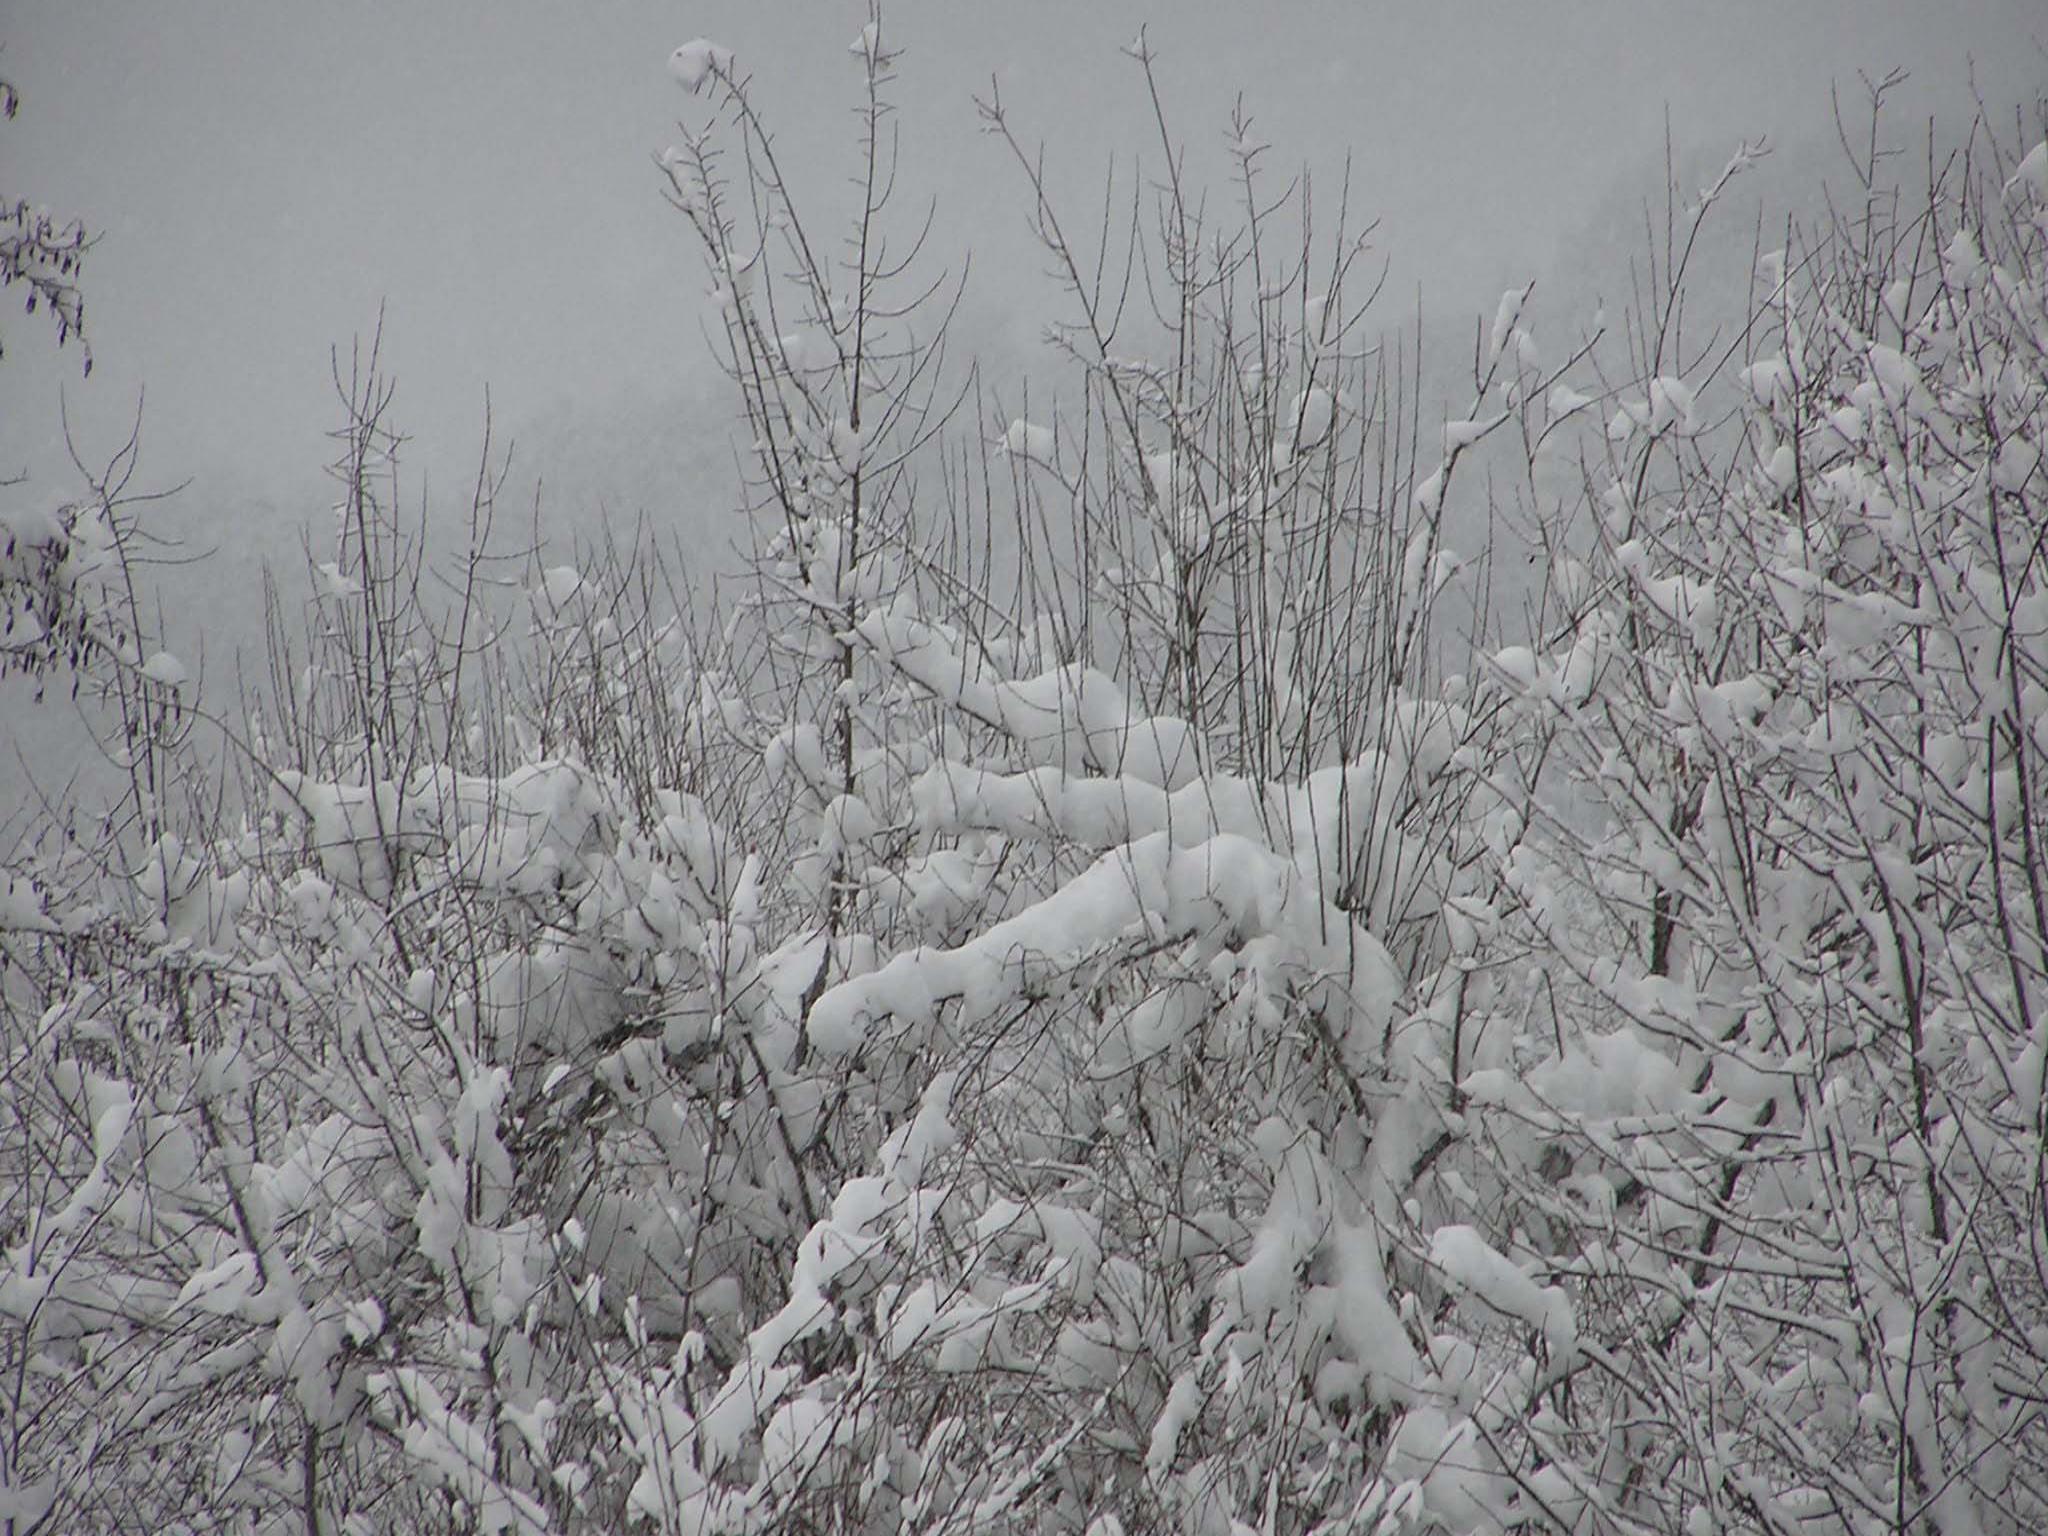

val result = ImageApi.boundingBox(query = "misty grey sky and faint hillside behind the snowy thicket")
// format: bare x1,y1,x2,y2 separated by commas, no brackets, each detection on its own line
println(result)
0,0,2048,827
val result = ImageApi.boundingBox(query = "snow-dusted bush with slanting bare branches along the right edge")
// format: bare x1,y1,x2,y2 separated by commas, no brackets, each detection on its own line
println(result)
1430,102,2048,1532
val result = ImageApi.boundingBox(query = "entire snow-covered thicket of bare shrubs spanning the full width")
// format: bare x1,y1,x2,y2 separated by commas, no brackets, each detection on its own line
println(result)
0,30,2048,1536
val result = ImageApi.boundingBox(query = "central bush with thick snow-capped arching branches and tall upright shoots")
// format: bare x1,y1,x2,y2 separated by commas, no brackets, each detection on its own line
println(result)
618,25,1479,1530
